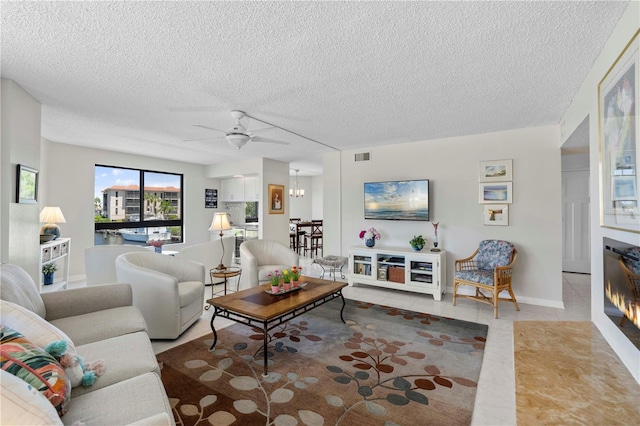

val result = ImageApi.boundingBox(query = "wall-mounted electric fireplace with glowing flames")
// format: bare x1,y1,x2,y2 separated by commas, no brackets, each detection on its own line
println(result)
602,238,640,349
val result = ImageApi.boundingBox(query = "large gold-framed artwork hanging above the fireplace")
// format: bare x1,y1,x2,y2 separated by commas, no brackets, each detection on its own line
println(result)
598,30,640,233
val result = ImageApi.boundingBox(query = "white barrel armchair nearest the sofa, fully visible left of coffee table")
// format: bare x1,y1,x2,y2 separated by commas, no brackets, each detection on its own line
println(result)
116,252,205,339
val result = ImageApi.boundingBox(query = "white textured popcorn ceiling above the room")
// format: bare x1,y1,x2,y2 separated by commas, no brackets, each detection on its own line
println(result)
0,1,628,175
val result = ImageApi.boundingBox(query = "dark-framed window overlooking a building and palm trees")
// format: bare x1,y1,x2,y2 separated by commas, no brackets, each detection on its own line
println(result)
94,164,184,246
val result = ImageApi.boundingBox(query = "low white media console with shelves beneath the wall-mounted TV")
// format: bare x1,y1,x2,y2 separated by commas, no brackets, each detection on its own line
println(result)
349,247,447,301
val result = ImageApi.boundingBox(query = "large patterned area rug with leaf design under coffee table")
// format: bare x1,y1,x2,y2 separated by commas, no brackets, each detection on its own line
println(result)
158,299,488,426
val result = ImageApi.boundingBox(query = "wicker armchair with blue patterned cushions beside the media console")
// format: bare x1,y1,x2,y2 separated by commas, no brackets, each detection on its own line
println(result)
453,240,520,318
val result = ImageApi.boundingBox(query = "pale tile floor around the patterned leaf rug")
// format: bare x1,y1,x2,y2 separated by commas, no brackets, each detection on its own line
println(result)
104,257,631,426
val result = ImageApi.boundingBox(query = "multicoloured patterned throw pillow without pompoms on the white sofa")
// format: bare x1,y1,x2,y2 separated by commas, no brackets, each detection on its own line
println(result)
0,325,71,416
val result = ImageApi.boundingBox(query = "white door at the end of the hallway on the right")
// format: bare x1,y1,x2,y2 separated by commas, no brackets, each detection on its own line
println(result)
562,170,591,274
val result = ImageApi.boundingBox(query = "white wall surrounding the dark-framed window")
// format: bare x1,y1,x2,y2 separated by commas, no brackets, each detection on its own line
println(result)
41,140,222,280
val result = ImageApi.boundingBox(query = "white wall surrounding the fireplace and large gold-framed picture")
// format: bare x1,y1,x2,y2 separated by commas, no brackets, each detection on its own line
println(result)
560,1,640,383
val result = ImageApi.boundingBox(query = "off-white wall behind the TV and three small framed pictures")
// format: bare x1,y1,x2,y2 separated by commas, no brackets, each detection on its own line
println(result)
324,126,563,309
